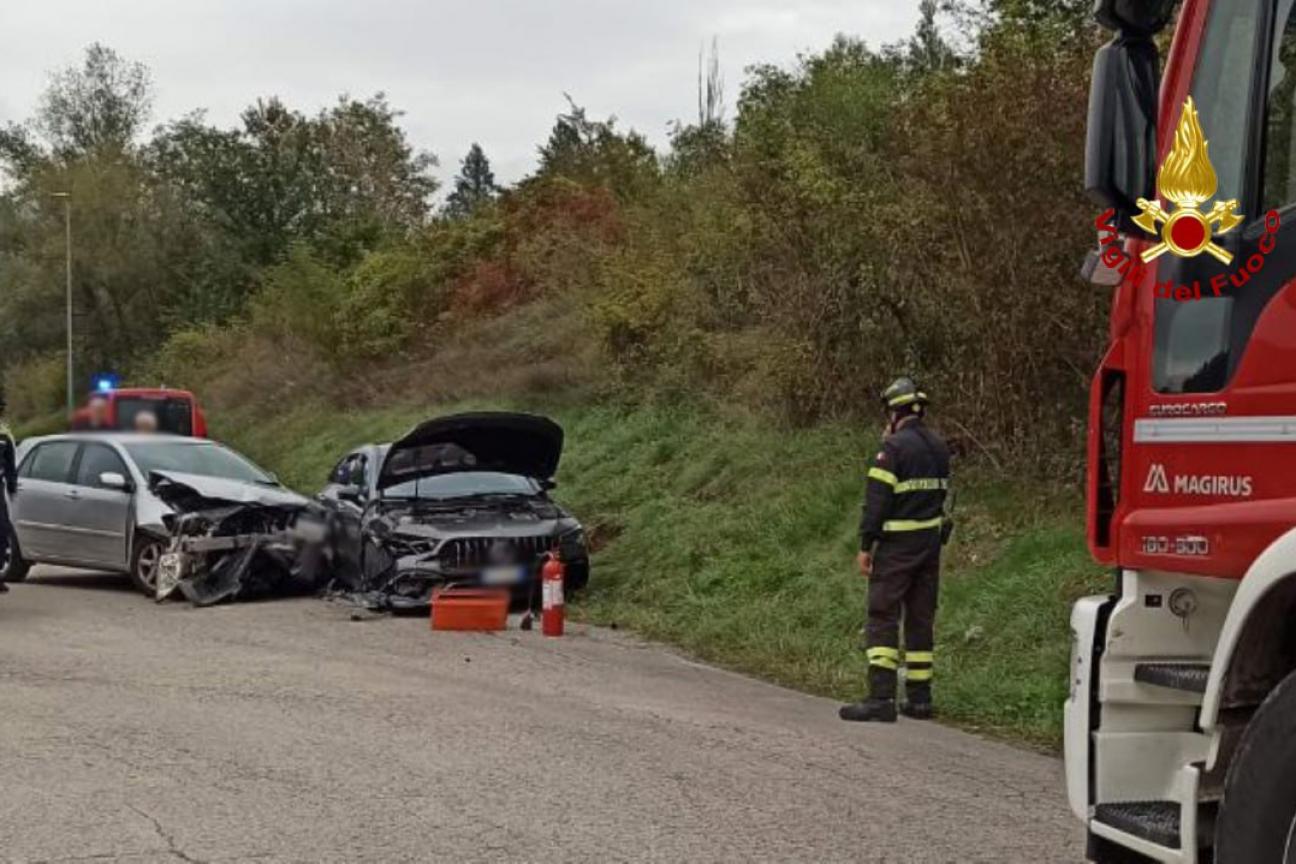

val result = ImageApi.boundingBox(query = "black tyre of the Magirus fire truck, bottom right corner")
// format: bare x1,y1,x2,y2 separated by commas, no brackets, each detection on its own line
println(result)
1214,672,1296,864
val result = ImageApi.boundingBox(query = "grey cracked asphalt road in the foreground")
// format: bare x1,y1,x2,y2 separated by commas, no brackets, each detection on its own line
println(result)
0,570,1082,864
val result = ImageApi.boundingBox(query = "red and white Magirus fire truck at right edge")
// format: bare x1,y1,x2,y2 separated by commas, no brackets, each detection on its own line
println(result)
1065,0,1296,864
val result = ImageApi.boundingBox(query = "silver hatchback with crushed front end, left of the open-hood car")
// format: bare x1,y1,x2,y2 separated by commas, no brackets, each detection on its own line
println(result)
4,433,328,605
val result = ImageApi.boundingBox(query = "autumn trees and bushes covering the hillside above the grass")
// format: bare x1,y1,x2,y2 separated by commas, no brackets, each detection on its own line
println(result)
0,0,1109,470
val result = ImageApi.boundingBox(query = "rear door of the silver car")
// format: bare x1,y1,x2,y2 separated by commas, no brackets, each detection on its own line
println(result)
12,440,80,561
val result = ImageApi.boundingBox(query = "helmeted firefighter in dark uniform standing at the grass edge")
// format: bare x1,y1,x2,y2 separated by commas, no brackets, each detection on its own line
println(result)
841,378,950,723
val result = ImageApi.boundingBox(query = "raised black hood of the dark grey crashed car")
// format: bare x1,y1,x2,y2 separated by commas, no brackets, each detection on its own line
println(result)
378,412,562,490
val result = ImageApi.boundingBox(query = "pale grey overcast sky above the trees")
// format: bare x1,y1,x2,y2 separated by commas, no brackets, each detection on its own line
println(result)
0,0,918,190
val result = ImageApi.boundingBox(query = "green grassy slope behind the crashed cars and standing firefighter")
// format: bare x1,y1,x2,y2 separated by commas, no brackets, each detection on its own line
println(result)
216,403,1105,746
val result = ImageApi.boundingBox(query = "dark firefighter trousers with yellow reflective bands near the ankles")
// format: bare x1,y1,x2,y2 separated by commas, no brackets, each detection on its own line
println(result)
866,538,941,702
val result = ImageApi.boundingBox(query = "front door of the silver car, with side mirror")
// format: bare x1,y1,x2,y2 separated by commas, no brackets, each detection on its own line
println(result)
66,442,132,570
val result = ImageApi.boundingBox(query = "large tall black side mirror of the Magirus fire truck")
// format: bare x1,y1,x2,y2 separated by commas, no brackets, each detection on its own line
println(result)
1085,35,1160,231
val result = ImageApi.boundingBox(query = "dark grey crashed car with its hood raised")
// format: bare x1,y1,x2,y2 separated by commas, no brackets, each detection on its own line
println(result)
319,412,590,609
